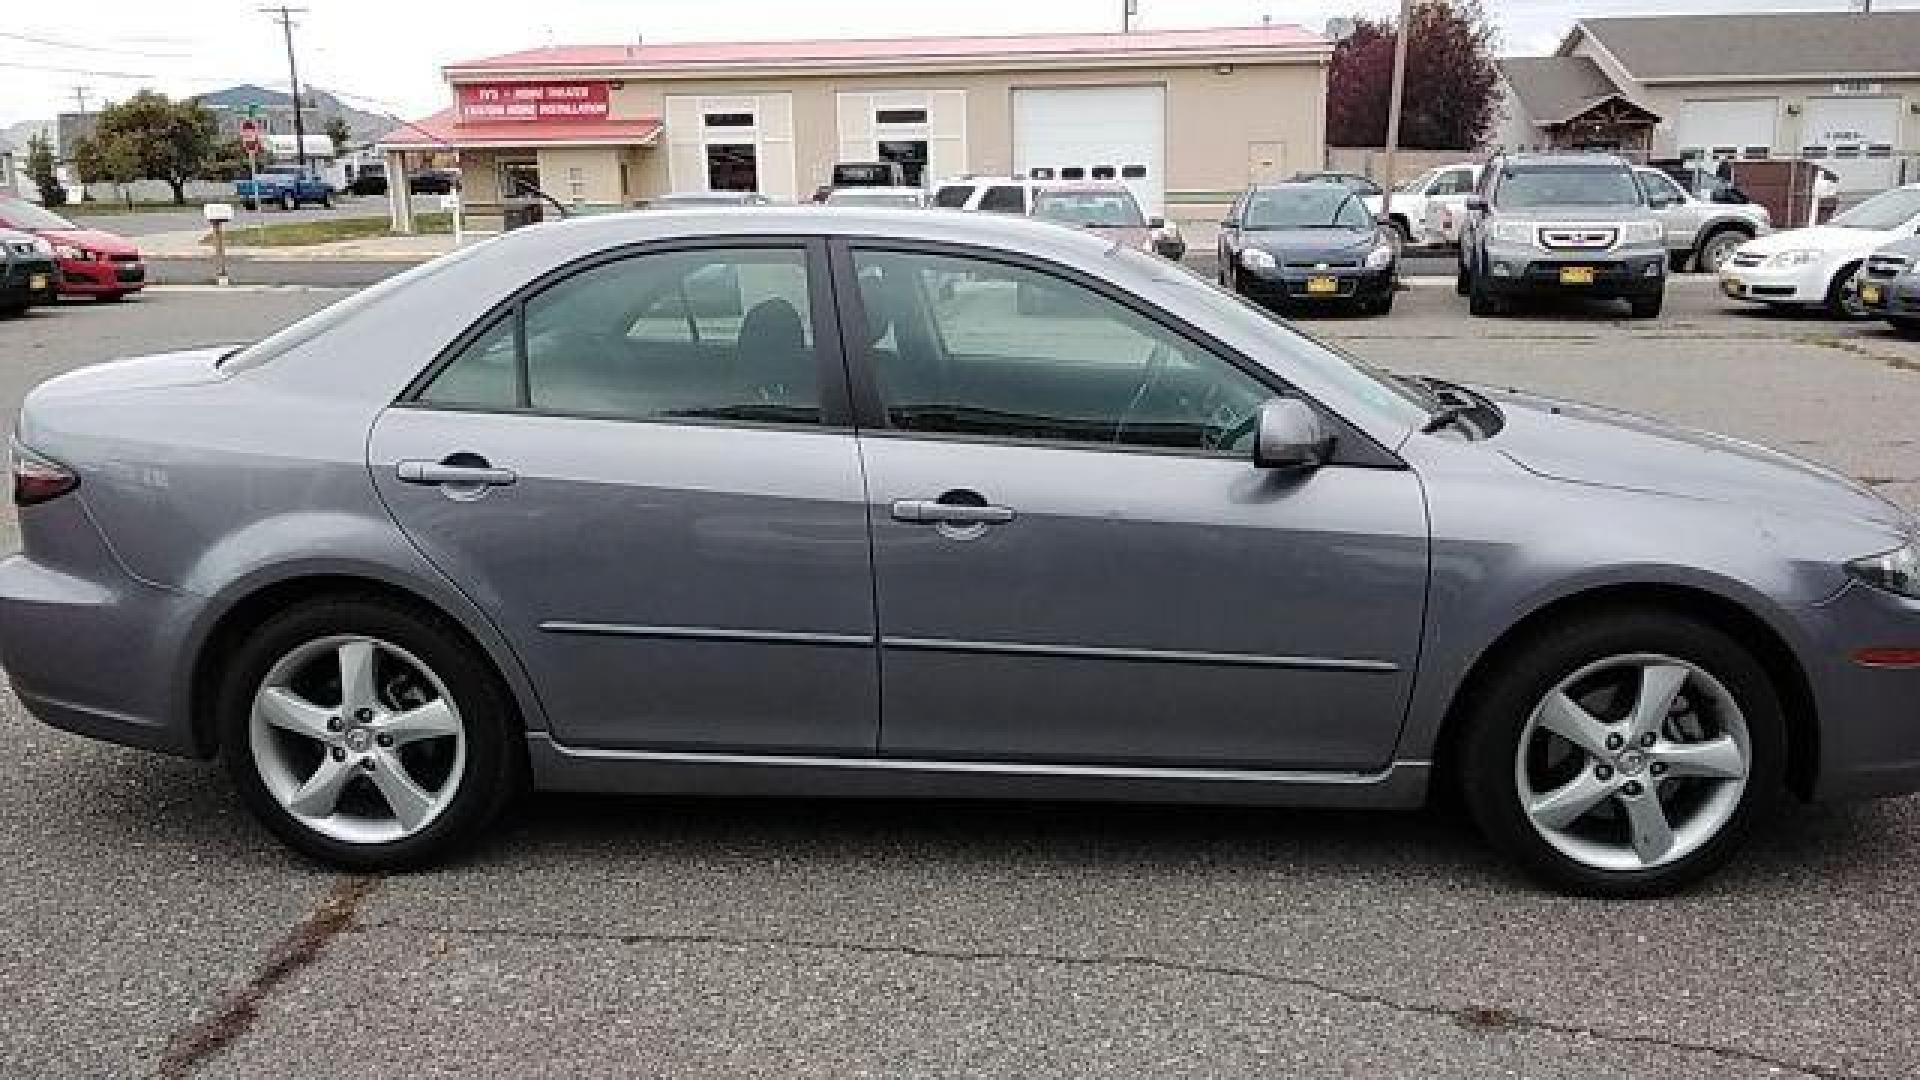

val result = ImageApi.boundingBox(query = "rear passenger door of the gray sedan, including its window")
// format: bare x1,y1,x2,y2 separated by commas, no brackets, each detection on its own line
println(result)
369,238,877,755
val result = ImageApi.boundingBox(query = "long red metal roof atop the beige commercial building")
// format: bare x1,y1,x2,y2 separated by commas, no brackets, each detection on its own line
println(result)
447,23,1327,71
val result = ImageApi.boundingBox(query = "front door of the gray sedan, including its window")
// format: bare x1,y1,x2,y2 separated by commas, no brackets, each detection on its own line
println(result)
839,242,1427,771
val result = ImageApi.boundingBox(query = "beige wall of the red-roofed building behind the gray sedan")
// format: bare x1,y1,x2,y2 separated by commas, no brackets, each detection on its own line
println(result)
591,60,1327,217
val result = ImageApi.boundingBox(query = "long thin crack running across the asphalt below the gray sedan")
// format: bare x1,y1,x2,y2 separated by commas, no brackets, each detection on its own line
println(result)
353,919,1864,1080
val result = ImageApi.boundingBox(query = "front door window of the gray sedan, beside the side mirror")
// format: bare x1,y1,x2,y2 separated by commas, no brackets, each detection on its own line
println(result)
854,252,1273,455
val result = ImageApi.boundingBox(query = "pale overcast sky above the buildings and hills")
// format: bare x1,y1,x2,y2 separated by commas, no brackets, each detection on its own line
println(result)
0,0,1920,127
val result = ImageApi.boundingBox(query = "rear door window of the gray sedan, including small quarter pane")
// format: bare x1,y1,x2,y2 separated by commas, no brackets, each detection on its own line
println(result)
420,248,820,423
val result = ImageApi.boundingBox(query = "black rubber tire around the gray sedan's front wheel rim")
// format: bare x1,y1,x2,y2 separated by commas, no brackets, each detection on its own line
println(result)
1457,607,1788,897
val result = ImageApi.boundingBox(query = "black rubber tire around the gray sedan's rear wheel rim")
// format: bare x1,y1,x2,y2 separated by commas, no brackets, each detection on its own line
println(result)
215,596,526,872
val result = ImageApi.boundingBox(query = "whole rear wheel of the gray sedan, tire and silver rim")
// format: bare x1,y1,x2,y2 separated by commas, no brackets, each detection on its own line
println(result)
219,598,522,871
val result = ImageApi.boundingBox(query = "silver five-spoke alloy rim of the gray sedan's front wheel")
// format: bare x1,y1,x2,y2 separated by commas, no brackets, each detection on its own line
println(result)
1513,653,1753,871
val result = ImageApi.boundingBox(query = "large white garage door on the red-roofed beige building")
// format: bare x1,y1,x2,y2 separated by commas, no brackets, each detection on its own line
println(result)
1014,86,1167,215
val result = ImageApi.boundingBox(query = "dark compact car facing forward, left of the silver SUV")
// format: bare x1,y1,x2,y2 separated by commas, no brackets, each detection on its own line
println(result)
1217,183,1400,315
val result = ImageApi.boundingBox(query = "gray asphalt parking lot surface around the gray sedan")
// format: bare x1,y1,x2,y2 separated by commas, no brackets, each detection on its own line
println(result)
0,279,1920,1080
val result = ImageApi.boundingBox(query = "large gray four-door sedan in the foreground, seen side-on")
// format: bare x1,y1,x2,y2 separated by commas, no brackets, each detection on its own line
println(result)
0,208,1920,896
